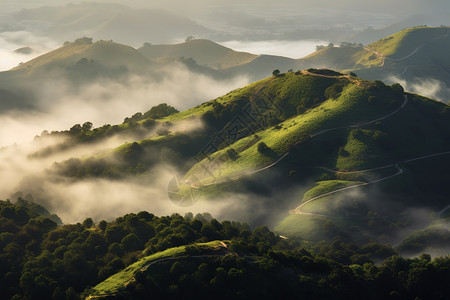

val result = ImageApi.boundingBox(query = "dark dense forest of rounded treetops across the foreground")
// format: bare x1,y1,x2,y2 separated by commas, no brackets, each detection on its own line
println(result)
0,199,450,299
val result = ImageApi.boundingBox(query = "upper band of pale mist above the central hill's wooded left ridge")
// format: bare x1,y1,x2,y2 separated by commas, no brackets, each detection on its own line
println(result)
0,65,249,146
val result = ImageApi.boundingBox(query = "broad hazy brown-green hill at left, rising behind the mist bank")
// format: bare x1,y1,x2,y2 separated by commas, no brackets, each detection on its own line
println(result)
0,37,227,111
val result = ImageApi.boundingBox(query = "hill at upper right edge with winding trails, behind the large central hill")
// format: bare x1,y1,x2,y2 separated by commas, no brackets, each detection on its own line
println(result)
300,26,450,102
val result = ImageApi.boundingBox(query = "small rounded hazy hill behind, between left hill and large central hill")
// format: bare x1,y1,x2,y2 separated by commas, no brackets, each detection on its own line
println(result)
138,39,258,69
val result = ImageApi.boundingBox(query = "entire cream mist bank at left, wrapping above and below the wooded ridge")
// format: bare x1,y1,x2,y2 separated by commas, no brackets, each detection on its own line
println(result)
0,60,253,223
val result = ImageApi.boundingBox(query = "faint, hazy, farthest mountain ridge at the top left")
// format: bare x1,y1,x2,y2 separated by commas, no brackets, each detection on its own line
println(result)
0,2,210,45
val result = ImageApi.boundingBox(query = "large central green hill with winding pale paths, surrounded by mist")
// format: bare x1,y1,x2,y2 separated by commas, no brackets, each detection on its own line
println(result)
30,70,450,242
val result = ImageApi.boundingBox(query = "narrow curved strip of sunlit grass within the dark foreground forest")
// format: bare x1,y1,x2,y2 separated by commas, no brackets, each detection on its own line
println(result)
92,241,225,296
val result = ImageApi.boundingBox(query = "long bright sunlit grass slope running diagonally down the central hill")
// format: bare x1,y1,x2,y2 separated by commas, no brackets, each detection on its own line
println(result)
183,79,398,183
